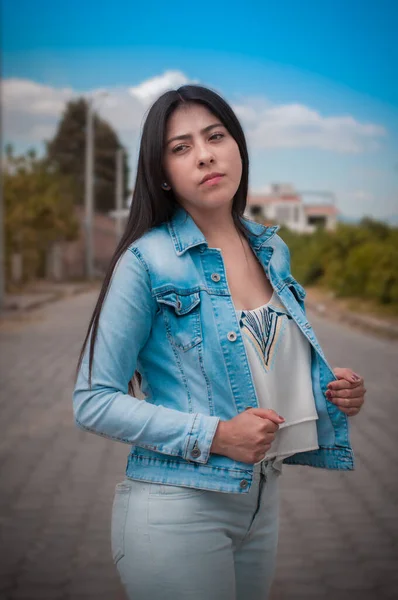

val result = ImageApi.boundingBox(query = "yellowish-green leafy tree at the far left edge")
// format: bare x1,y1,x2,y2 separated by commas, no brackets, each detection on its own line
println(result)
3,146,79,280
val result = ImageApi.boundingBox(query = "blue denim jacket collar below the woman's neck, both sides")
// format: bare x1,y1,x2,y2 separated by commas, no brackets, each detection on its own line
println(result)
167,206,280,256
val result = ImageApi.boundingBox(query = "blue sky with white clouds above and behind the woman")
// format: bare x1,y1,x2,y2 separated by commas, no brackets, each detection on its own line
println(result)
1,0,398,218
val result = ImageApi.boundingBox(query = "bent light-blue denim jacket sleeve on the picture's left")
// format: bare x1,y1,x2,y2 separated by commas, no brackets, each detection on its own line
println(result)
73,248,220,463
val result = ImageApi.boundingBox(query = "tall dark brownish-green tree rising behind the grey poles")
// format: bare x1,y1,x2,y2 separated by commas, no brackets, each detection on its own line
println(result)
47,98,129,212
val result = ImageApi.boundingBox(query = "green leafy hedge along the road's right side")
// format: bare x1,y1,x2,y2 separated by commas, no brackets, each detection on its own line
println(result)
279,218,398,308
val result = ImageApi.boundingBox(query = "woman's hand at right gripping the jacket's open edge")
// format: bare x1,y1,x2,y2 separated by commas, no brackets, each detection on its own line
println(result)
326,367,366,417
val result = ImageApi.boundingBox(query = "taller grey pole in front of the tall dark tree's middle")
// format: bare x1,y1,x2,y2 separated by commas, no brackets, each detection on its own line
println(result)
84,98,94,279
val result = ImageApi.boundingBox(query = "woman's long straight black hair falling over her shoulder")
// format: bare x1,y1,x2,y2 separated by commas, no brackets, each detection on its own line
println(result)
77,85,256,393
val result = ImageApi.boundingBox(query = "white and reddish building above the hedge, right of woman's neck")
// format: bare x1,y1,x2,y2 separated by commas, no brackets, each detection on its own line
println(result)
245,184,338,233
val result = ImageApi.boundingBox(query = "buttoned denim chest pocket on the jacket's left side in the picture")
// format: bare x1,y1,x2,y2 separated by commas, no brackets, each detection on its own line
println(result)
156,292,203,352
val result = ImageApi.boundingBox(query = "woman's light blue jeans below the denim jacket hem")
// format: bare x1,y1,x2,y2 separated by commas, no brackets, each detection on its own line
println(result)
112,460,280,600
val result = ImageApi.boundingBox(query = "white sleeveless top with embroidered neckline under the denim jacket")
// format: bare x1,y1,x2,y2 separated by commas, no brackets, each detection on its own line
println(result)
236,292,319,470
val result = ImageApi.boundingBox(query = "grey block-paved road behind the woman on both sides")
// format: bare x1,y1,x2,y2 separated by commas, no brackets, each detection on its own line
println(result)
0,293,398,600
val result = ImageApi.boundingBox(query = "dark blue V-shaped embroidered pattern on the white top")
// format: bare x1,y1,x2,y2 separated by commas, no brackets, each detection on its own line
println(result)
239,302,292,372
